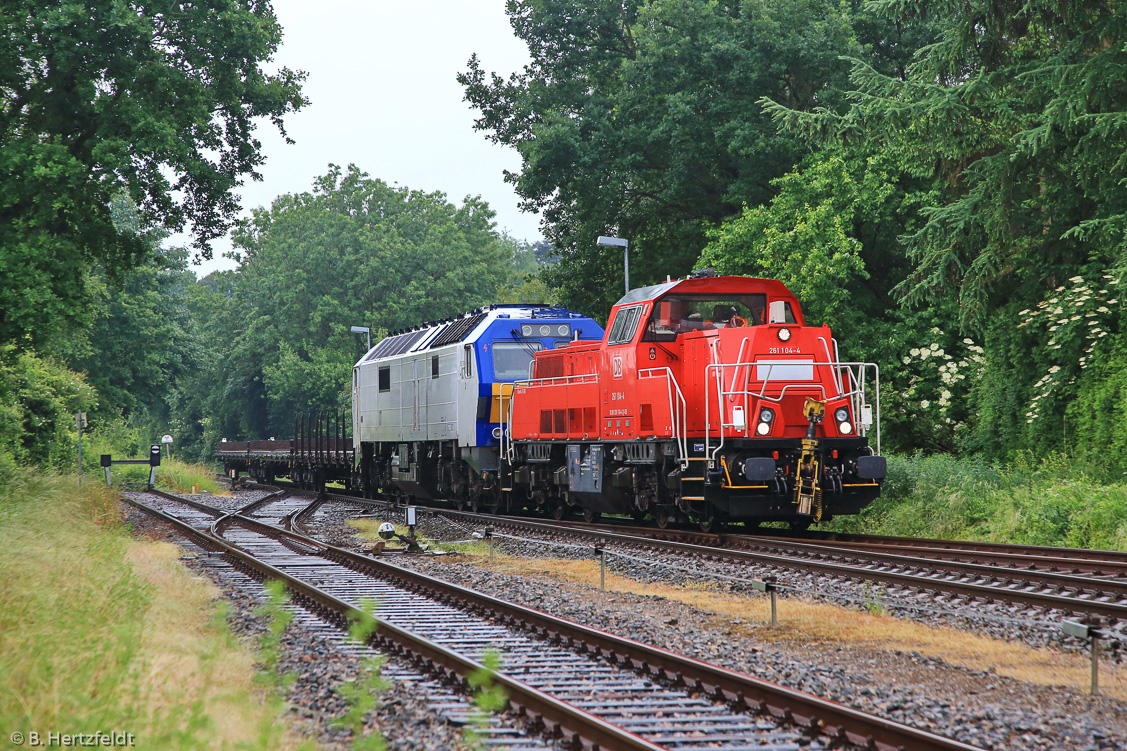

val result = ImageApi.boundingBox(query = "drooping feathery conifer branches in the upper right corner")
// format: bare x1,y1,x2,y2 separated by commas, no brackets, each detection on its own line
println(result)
763,0,1127,326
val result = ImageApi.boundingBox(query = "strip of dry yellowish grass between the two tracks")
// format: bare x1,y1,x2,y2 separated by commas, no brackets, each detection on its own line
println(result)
468,554,1127,699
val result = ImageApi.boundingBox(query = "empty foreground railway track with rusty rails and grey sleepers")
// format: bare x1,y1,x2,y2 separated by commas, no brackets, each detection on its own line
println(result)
130,484,974,751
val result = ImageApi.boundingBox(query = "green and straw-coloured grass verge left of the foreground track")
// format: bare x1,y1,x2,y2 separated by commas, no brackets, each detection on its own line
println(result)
0,470,306,751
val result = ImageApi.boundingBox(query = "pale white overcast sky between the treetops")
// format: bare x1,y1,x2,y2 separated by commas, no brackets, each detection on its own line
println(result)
185,0,541,276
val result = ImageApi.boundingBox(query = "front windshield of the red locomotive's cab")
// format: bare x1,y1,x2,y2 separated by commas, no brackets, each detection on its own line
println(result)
641,294,795,342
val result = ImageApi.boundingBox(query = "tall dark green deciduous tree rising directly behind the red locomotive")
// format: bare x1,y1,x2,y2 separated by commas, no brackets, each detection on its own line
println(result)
459,0,866,315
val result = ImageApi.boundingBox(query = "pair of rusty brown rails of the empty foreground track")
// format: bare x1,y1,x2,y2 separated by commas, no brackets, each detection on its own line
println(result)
131,491,977,751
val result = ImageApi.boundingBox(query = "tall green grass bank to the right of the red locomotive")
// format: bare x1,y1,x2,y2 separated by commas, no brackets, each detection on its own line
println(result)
822,456,1127,550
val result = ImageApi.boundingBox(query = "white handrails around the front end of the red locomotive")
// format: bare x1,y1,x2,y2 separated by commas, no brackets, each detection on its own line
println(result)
704,356,880,466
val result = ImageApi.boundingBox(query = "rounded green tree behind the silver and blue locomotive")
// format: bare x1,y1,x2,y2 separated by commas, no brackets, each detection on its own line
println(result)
199,166,518,439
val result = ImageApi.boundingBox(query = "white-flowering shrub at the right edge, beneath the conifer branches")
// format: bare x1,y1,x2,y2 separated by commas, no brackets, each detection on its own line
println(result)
1018,274,1119,423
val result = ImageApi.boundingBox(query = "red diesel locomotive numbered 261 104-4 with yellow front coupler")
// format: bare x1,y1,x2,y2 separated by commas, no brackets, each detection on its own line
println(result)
499,272,886,530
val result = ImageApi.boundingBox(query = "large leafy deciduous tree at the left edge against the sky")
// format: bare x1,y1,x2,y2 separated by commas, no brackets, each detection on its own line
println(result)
0,0,305,346
